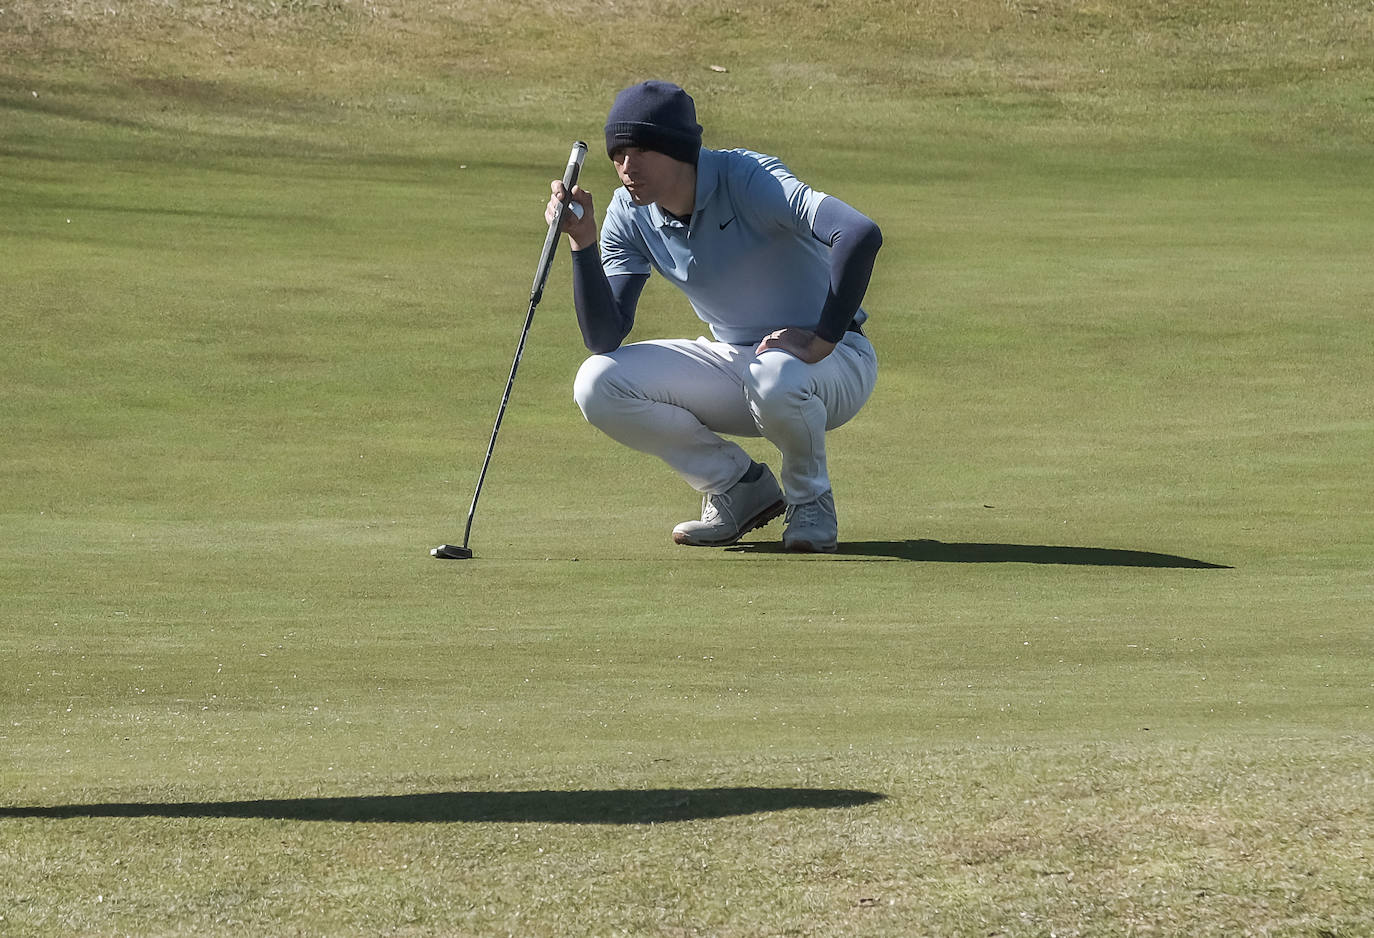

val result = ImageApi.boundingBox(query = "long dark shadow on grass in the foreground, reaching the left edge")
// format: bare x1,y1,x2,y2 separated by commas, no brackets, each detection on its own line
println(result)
0,788,886,824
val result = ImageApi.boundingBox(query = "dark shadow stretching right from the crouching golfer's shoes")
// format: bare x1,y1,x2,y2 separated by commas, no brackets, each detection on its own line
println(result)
727,540,1231,570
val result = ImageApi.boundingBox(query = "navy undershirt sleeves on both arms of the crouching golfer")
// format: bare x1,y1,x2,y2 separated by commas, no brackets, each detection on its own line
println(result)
573,196,882,354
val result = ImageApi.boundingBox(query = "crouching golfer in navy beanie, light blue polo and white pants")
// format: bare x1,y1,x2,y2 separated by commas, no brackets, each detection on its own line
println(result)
545,81,882,551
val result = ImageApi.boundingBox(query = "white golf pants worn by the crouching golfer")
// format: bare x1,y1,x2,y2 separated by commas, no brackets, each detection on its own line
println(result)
573,332,878,504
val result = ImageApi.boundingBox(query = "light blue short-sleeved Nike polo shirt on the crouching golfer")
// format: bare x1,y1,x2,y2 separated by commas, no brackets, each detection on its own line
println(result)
600,148,830,345
